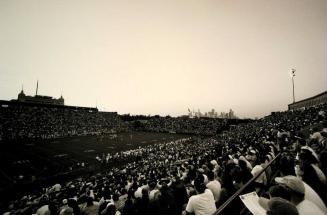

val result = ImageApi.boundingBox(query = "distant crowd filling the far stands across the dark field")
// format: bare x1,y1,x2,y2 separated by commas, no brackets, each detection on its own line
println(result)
0,105,238,140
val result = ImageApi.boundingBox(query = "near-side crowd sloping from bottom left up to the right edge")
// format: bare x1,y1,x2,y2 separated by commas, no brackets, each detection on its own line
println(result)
0,105,327,215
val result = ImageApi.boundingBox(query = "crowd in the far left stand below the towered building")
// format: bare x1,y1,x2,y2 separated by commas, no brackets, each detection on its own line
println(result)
0,106,123,140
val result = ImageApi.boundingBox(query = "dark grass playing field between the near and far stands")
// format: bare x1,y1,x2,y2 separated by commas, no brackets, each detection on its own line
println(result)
0,132,191,194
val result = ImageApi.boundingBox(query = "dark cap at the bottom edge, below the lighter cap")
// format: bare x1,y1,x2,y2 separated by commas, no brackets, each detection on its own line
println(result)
259,197,299,215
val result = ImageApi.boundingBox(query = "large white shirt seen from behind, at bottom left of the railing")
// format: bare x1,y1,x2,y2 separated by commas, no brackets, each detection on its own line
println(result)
186,189,216,215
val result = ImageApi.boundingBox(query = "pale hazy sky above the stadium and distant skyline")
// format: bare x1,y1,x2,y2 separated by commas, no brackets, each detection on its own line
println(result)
0,0,327,118
